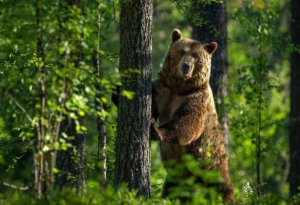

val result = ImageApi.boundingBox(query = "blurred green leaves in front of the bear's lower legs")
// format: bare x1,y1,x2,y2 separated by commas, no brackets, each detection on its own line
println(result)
166,155,223,204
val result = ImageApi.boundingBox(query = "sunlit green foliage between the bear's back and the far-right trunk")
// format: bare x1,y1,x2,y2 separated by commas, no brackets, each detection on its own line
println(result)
228,1,289,203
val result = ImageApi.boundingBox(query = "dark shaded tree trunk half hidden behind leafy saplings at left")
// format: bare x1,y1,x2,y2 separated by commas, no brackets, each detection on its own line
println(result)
56,0,86,191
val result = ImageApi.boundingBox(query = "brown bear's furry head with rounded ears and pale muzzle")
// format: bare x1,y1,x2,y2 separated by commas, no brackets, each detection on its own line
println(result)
162,29,218,90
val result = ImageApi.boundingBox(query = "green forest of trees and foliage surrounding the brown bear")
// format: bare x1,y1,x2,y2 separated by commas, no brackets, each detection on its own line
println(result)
0,0,300,204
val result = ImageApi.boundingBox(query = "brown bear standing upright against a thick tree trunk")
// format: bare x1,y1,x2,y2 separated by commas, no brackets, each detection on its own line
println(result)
151,29,232,201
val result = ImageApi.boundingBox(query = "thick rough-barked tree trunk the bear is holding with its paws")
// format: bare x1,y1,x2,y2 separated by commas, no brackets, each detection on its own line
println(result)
115,0,153,197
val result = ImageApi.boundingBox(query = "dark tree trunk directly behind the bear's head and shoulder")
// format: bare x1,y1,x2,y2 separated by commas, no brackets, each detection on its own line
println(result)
192,0,228,142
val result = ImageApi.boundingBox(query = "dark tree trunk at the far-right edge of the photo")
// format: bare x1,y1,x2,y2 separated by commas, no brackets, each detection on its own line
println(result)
289,0,300,196
